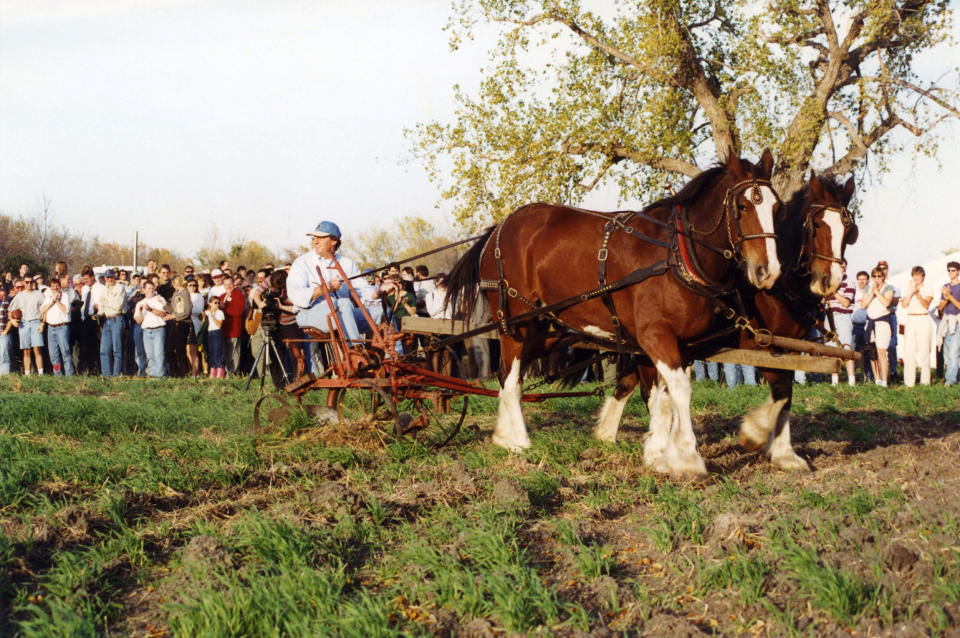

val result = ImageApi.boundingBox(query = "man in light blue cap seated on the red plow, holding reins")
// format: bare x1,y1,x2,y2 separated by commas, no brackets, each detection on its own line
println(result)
287,221,380,346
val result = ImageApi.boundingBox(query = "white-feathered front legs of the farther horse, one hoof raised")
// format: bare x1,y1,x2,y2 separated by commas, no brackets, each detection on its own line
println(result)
739,370,810,471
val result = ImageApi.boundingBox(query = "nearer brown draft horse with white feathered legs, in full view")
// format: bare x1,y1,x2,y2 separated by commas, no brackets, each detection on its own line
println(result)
447,150,781,476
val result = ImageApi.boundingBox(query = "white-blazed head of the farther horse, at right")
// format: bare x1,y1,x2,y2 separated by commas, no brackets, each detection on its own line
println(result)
799,171,859,297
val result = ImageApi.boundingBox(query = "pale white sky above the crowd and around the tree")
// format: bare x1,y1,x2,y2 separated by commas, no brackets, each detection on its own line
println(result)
0,0,960,272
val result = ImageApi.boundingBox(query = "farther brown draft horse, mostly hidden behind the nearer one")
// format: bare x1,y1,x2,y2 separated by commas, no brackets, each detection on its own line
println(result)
632,173,858,472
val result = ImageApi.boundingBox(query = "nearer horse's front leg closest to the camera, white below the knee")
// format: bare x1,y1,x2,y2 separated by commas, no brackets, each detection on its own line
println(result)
644,324,707,479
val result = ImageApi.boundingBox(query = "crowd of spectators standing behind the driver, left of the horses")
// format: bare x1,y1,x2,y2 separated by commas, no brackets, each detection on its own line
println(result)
0,248,489,380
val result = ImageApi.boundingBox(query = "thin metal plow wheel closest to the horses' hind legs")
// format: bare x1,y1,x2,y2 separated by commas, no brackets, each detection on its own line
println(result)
395,390,470,449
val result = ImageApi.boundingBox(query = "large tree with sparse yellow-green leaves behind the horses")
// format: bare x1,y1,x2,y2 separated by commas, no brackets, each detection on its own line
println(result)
410,0,960,228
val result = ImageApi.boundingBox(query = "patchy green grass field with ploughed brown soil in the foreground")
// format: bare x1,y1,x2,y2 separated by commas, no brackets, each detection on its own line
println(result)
0,377,960,636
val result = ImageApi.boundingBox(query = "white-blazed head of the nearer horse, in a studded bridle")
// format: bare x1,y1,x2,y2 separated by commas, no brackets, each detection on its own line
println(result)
723,149,781,289
